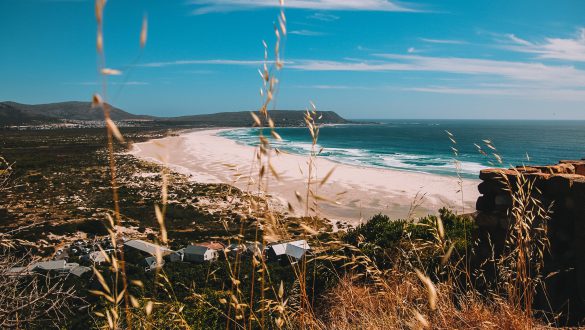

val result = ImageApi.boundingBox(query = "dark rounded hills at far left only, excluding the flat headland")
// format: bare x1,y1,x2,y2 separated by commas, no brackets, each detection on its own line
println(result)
0,101,150,124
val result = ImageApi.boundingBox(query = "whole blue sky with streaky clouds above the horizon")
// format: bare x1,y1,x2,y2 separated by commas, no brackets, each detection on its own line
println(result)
0,0,585,119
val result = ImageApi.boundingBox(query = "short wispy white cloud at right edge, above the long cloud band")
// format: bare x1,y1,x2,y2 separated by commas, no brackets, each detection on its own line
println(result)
505,28,585,62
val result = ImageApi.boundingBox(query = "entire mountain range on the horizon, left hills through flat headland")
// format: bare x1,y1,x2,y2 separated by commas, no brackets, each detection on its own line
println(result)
0,101,349,127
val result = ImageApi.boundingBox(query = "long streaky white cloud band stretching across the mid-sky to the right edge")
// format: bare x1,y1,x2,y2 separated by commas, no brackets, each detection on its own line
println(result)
142,54,585,101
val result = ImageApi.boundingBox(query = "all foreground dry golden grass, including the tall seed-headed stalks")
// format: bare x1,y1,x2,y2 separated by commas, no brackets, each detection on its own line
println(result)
0,0,560,329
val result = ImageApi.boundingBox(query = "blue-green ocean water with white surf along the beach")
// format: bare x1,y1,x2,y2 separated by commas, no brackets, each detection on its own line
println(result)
220,120,585,178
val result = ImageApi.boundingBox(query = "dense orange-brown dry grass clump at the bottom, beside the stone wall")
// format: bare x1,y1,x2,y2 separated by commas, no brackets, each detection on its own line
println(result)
321,272,539,330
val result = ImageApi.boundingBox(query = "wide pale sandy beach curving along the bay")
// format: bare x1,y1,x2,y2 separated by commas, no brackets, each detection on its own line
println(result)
130,129,480,225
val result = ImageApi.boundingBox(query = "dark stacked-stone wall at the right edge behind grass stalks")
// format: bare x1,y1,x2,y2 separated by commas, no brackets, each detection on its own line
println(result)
476,160,585,324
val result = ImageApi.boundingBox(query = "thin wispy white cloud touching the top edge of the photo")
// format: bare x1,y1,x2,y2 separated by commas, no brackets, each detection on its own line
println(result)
191,0,418,15
